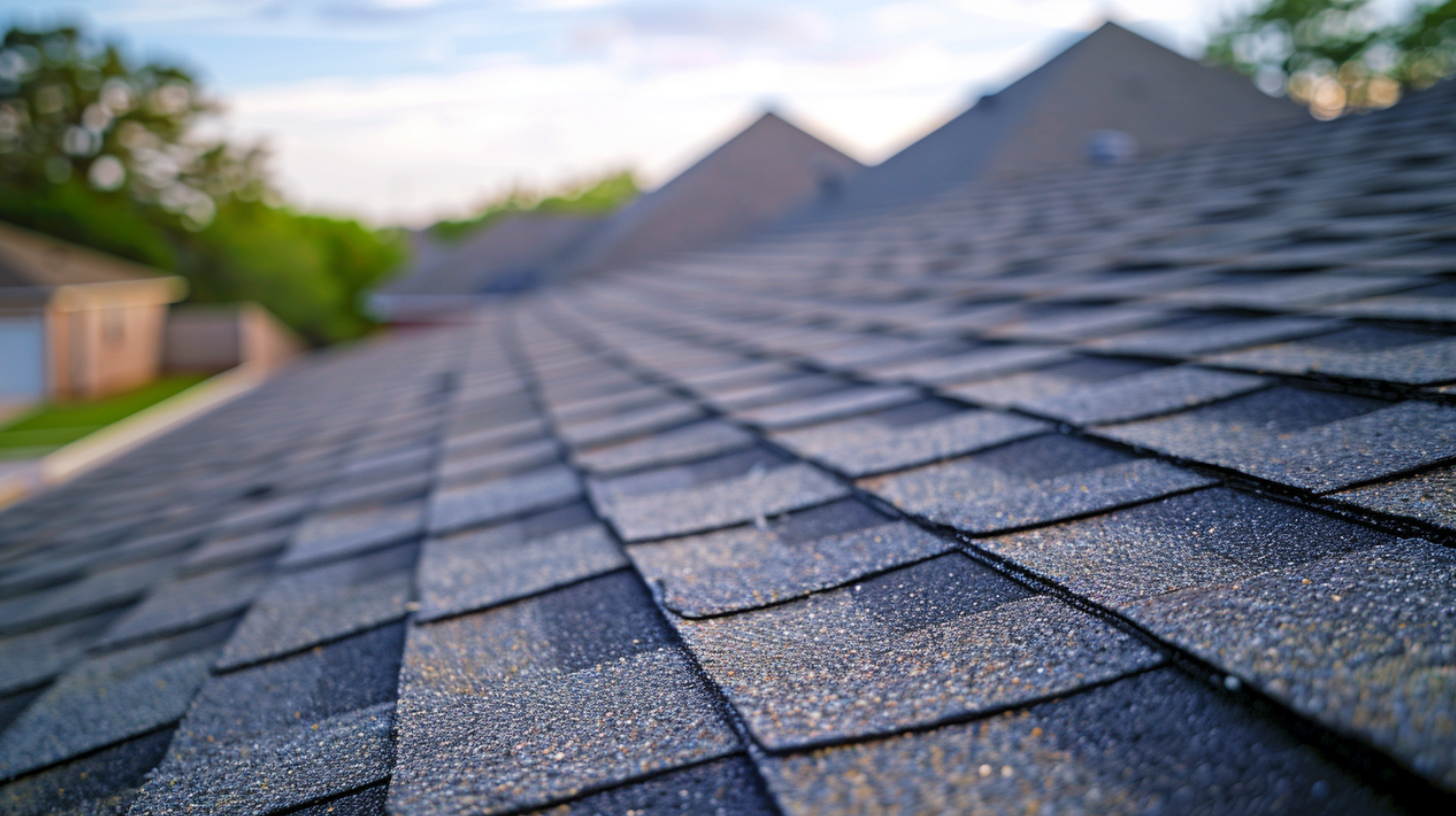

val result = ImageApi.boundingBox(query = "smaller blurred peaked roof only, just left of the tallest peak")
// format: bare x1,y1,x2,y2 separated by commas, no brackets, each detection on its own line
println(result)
550,112,860,271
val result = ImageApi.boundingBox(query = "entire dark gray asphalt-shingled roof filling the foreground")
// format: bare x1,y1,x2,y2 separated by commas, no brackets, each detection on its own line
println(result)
0,65,1456,816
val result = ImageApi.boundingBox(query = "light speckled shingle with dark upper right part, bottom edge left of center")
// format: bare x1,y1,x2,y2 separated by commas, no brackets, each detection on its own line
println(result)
390,573,738,816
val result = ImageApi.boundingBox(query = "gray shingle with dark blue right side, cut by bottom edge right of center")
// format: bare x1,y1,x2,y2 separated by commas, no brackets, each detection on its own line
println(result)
760,669,1399,816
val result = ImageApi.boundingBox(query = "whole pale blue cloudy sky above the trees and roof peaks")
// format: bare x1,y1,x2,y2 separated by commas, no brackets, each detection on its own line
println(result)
0,0,1251,224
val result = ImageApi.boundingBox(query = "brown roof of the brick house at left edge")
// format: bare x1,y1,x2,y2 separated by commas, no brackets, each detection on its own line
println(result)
0,223,182,302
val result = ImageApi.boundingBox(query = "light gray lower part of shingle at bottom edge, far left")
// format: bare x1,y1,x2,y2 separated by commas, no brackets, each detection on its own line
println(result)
130,702,395,816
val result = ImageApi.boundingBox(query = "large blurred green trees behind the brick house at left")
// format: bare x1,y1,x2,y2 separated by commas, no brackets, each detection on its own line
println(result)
0,26,406,344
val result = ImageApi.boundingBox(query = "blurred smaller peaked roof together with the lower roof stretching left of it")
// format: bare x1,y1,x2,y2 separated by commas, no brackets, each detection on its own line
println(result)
371,107,860,313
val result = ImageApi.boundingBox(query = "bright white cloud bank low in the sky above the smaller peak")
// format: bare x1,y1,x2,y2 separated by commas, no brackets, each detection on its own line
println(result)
230,29,1042,223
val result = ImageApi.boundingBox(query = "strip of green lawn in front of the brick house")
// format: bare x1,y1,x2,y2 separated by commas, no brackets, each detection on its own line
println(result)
0,374,207,459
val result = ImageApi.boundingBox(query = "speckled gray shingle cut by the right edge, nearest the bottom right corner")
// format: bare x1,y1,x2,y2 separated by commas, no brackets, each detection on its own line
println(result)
1125,541,1456,791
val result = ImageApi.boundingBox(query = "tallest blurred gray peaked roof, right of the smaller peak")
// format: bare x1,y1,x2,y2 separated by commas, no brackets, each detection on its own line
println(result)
798,23,1309,219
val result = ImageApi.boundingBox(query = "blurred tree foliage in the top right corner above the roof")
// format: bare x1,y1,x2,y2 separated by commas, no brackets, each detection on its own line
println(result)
1204,0,1456,119
